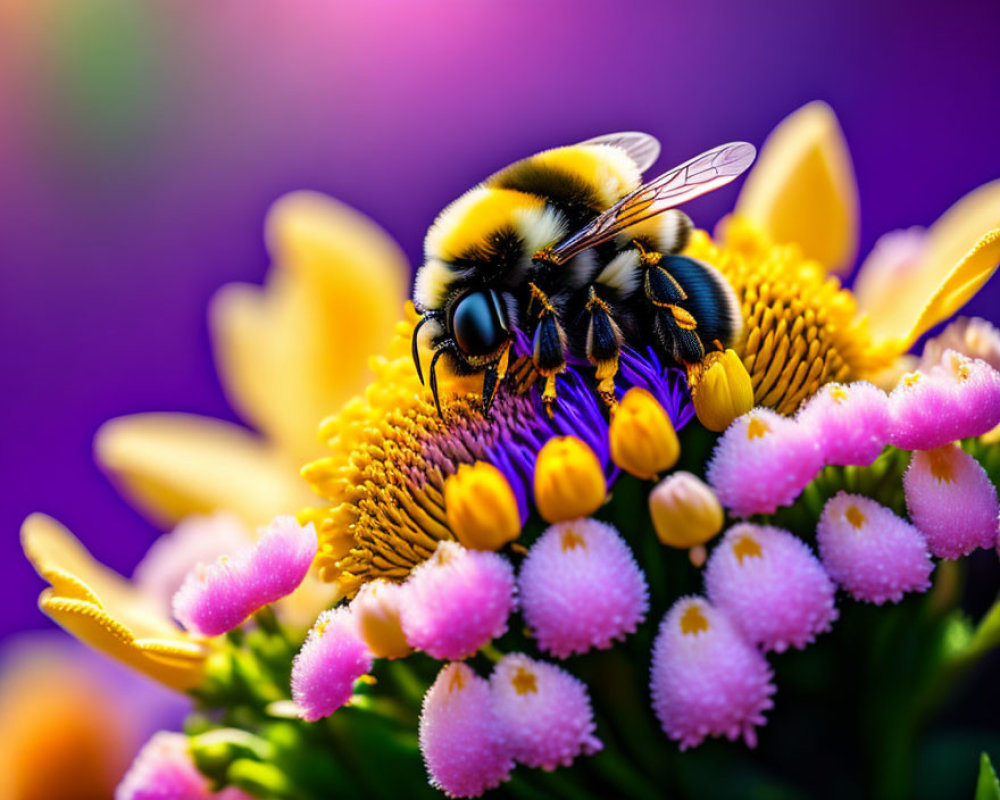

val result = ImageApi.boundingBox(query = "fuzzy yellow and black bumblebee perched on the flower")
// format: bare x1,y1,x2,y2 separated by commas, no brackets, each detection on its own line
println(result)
413,132,756,415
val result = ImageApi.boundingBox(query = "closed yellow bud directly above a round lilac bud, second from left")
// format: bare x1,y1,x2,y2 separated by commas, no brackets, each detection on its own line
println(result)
534,436,607,523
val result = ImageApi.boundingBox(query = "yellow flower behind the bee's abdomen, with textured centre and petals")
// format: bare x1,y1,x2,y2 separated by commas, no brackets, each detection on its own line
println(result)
716,103,1000,414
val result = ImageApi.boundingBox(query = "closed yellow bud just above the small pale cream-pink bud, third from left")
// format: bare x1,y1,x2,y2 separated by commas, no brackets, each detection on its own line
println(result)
608,386,681,478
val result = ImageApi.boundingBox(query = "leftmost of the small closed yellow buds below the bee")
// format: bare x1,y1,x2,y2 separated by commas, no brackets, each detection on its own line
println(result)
444,461,521,550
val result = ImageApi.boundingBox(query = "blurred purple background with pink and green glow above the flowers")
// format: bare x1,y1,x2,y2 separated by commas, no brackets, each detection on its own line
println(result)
0,0,1000,634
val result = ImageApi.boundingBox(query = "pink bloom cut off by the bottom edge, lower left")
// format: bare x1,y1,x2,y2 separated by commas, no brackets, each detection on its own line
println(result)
115,731,250,800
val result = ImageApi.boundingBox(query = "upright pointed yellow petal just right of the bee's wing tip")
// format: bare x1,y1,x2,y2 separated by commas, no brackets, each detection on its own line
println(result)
736,101,859,272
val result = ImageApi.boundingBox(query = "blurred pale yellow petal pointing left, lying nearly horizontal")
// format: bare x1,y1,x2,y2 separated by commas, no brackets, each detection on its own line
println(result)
94,414,312,527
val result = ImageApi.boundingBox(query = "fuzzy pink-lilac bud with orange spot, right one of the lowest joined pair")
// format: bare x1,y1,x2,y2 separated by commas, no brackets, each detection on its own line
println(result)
490,653,602,770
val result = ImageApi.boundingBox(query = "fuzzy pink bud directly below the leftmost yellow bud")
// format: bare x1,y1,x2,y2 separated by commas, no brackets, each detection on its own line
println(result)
400,542,514,659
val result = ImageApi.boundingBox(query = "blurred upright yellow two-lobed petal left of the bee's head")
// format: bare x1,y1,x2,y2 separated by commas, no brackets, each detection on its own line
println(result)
210,192,409,461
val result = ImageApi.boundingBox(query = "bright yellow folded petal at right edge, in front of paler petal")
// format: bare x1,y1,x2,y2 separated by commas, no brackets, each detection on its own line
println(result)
866,228,1000,355
